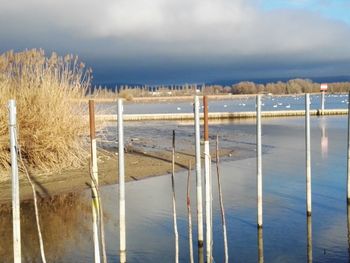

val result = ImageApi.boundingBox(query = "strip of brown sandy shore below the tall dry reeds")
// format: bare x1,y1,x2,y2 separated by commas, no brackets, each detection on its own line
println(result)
0,149,238,204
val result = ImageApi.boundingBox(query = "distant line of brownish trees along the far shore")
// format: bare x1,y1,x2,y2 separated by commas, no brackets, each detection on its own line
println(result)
89,79,350,100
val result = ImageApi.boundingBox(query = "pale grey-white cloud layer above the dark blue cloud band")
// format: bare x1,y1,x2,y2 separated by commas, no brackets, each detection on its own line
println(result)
0,0,350,75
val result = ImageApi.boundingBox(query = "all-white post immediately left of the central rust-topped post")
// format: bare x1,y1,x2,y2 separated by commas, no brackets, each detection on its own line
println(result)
194,96,203,247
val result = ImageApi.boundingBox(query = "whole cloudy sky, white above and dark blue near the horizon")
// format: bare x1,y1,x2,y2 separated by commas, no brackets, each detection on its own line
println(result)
0,0,350,84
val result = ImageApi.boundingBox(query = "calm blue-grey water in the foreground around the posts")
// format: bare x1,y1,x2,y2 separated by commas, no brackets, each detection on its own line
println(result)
0,111,350,262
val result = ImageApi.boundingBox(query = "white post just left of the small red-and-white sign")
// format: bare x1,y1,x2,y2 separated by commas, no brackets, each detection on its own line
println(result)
305,94,311,216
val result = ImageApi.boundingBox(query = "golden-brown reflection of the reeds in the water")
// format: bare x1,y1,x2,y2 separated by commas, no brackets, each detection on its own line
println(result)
0,194,91,262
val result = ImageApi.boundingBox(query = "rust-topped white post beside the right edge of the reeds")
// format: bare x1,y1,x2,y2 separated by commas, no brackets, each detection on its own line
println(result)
89,100,101,263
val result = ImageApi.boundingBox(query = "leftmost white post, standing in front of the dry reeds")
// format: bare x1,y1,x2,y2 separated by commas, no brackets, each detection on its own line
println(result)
8,100,22,263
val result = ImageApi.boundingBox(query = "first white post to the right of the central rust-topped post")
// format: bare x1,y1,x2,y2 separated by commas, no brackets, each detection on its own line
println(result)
256,95,263,228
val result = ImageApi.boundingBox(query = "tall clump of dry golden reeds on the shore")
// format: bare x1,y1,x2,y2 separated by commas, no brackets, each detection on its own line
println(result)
0,49,91,172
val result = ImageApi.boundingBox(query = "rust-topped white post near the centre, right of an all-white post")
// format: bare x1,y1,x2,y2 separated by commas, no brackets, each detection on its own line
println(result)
203,96,212,263
